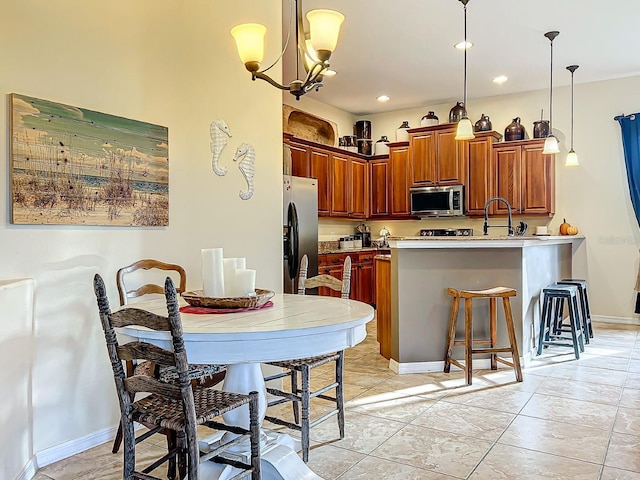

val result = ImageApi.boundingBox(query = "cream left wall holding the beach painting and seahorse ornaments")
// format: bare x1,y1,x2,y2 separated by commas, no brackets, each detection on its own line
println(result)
0,0,282,466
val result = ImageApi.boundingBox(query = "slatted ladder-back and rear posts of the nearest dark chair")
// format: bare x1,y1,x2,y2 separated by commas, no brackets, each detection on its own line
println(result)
93,274,200,478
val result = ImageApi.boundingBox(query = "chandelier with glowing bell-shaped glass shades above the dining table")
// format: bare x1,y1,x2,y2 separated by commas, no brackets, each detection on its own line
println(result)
231,0,344,100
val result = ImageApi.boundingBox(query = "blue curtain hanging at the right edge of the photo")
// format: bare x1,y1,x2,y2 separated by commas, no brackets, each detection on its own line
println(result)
614,113,640,313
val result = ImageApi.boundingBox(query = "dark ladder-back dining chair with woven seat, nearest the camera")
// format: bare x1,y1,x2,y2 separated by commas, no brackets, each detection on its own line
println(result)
93,274,261,480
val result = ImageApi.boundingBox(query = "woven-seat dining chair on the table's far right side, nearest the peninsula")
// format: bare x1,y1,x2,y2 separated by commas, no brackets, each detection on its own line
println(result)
265,255,351,462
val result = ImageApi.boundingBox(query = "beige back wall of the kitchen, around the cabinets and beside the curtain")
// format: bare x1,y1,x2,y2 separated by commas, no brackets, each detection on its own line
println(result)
311,76,640,318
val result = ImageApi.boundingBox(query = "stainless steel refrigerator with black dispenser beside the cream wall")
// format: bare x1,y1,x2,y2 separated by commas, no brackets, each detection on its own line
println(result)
283,175,318,293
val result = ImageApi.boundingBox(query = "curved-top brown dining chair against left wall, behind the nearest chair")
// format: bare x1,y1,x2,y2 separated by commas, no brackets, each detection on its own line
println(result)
111,259,226,453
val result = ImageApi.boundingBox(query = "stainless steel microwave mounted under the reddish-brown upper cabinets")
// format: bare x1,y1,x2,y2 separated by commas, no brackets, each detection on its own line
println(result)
410,185,464,217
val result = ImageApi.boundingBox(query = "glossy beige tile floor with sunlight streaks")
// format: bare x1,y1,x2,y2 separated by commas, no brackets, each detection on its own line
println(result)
35,322,640,480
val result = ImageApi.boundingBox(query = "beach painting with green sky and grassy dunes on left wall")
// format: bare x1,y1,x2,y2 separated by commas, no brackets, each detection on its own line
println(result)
10,93,169,226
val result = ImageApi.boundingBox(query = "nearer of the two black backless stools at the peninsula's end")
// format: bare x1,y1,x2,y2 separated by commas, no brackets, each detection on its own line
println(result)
538,284,584,359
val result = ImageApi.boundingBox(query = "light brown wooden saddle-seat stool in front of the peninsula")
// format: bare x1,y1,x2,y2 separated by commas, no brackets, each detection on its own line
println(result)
444,287,522,385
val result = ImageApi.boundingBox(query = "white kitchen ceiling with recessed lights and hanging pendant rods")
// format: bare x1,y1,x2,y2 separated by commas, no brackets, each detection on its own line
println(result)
282,0,640,115
